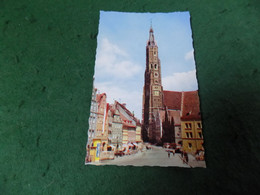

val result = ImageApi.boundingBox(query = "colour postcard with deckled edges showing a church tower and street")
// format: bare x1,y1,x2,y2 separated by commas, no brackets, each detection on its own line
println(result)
85,11,206,168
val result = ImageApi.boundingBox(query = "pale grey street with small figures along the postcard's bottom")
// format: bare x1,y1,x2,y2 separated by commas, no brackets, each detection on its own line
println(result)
89,146,206,168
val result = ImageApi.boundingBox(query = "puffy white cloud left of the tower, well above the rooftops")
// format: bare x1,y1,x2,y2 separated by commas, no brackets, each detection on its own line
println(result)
96,38,141,78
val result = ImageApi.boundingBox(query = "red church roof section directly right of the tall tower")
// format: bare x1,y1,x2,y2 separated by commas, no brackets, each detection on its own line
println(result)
163,91,182,110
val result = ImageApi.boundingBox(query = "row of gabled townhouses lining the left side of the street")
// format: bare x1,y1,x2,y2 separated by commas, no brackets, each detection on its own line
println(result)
86,88,142,163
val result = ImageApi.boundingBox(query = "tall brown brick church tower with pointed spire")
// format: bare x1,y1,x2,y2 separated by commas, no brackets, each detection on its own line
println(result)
142,27,164,143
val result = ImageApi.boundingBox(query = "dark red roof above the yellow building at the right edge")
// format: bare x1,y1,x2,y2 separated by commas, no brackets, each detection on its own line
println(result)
181,91,201,120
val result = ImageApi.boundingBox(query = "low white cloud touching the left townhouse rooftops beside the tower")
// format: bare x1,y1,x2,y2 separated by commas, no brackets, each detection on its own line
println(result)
95,82,142,120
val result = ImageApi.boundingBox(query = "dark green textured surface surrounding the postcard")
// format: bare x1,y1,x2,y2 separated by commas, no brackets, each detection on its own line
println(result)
0,0,260,194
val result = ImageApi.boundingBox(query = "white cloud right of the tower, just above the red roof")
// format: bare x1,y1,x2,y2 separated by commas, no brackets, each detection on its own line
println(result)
162,70,198,91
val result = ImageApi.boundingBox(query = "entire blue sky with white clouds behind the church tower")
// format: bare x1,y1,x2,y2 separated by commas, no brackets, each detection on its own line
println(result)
94,11,198,119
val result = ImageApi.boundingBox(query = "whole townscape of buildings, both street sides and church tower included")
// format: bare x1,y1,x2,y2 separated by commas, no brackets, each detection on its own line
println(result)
86,27,204,162
